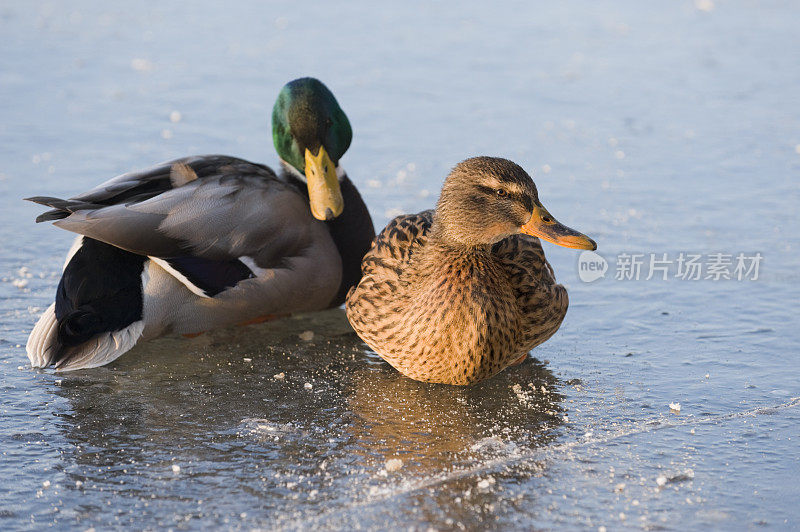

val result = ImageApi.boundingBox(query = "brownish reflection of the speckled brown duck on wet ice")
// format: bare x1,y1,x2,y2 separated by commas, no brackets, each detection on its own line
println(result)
347,361,562,474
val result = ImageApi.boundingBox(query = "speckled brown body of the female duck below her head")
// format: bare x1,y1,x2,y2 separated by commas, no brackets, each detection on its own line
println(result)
347,211,568,384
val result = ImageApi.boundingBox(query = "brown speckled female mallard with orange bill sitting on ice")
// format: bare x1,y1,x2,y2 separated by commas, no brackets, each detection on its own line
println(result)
347,157,597,384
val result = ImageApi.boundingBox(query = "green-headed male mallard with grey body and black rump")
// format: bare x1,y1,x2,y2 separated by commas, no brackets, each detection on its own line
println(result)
27,78,375,370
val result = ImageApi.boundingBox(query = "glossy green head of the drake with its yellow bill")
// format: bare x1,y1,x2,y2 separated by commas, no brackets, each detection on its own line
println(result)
272,78,353,220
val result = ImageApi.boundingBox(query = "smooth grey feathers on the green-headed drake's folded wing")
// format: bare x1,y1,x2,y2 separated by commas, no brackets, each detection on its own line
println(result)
55,178,313,267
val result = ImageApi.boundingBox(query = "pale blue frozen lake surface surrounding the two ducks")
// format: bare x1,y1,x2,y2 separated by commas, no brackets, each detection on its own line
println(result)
0,0,800,530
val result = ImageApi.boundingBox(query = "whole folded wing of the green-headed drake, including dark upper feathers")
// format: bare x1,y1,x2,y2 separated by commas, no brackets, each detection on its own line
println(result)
29,156,326,296
